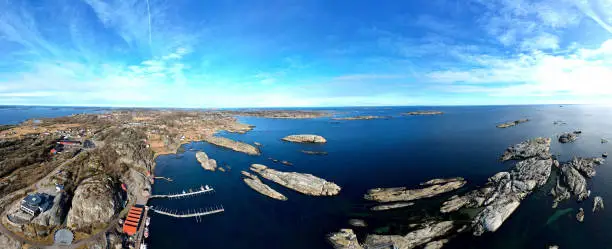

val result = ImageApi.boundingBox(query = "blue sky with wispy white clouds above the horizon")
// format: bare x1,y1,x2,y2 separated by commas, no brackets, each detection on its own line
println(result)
0,0,612,107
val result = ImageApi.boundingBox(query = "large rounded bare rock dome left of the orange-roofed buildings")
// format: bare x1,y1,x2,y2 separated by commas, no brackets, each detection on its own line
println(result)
67,177,120,230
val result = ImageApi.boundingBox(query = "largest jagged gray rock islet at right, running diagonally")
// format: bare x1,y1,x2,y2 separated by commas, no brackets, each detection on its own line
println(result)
440,138,553,235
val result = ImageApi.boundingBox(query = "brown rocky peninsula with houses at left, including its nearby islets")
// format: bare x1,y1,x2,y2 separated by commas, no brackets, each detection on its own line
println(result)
0,109,330,249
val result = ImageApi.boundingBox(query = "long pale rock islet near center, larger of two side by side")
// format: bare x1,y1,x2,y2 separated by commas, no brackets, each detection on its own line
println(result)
251,164,340,196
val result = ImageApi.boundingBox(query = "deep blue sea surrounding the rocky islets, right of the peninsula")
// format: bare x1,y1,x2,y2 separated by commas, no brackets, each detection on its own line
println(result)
0,105,612,249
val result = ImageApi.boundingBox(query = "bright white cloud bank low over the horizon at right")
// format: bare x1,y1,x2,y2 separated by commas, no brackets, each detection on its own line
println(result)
427,40,612,100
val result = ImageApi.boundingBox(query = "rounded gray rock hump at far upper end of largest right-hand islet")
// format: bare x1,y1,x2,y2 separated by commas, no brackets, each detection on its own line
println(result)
501,137,551,161
